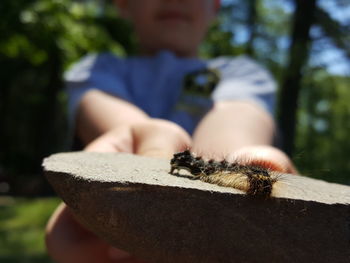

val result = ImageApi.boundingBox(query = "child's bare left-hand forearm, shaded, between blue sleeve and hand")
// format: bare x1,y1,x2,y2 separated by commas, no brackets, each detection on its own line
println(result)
76,90,149,144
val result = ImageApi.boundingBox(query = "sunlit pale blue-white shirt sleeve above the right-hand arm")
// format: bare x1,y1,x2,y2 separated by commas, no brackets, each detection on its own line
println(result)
209,56,276,115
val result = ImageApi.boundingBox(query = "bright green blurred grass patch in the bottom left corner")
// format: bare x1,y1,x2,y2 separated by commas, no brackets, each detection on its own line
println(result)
0,197,59,263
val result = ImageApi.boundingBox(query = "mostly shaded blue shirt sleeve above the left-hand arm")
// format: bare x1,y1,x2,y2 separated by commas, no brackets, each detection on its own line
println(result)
64,53,129,126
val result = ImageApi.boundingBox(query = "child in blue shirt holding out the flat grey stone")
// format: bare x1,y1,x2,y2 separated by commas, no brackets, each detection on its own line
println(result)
46,0,295,262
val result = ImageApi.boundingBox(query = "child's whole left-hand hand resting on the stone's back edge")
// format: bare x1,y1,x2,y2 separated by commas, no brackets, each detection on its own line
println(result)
85,119,191,158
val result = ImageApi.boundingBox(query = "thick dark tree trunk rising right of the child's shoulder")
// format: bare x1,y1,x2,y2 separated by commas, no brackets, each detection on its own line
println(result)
277,0,317,155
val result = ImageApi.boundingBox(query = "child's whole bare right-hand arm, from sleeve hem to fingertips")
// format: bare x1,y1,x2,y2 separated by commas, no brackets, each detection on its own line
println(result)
192,101,296,173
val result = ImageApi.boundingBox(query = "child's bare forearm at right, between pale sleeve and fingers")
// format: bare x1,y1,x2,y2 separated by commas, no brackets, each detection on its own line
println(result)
193,101,275,156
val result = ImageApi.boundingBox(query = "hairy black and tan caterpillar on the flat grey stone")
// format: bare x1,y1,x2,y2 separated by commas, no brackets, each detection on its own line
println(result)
170,150,279,197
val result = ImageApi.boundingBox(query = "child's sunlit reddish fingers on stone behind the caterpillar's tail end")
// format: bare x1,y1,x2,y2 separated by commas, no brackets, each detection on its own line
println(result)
233,145,298,174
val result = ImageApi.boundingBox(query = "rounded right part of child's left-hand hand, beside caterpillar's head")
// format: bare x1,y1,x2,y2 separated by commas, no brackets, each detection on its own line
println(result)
132,119,191,158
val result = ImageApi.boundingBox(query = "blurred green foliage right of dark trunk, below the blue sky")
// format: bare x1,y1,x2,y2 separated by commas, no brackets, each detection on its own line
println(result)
295,69,350,184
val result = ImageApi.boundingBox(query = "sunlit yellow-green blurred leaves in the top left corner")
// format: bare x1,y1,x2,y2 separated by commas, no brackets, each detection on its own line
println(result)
0,0,129,66
